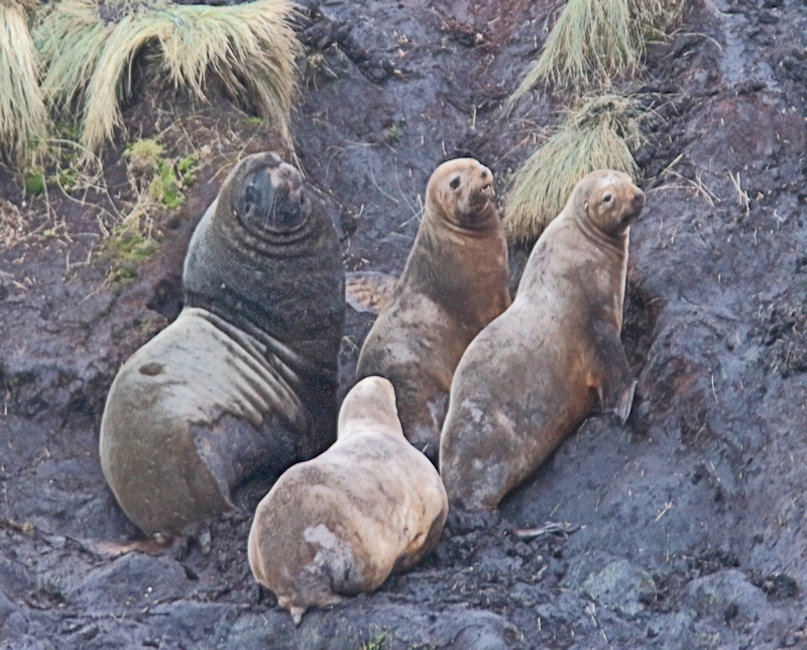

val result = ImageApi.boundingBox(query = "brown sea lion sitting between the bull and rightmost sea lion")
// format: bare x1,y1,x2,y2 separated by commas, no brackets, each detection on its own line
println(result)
356,158,510,461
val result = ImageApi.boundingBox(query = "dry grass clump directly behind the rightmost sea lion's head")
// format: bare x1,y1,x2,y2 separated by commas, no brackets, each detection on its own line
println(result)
504,95,642,242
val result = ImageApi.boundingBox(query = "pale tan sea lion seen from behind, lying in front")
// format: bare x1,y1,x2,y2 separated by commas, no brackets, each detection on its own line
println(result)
248,377,448,625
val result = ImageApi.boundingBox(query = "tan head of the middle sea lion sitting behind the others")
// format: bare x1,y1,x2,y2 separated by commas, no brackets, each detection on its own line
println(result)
426,158,496,229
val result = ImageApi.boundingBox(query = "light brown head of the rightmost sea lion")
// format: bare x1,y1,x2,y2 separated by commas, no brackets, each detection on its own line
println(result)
574,169,644,237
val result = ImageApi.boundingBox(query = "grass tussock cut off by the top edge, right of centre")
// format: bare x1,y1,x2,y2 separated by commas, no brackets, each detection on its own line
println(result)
508,0,685,106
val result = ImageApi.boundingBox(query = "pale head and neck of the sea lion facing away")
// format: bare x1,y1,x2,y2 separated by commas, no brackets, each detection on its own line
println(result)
337,376,403,438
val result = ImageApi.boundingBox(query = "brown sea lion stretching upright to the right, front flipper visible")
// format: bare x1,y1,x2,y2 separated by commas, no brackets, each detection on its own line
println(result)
440,170,644,509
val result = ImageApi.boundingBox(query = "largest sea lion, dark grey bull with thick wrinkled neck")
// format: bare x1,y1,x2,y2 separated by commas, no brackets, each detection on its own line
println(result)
100,153,345,537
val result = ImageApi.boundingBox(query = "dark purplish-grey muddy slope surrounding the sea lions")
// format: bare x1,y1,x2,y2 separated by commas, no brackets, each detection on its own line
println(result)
0,0,807,650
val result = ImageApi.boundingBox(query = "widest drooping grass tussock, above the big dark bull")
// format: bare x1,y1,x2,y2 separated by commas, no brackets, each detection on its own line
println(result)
36,0,300,151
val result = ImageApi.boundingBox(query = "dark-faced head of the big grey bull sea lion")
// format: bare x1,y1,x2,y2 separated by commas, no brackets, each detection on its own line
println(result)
219,152,311,239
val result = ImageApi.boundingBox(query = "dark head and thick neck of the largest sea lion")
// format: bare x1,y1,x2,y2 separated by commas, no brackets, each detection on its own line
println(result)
183,154,344,372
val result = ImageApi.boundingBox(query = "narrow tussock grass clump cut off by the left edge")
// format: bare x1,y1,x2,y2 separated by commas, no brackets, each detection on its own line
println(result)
0,0,48,165
